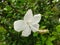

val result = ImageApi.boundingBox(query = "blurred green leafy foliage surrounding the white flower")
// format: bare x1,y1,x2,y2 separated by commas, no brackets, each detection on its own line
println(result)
0,0,60,45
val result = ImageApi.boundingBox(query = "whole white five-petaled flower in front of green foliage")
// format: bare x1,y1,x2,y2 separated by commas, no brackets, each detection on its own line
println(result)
14,9,41,37
